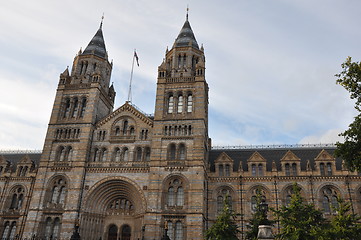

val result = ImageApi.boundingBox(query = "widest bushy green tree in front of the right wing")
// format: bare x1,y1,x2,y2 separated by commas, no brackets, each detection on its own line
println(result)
272,183,325,240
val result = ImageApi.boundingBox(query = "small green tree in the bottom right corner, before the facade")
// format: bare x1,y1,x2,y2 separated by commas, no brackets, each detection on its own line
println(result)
326,198,361,240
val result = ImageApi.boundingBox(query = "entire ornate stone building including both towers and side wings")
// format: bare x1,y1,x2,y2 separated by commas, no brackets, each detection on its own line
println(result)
0,16,361,240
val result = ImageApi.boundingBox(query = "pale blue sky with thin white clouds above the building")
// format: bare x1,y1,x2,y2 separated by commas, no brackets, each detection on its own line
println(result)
0,0,361,150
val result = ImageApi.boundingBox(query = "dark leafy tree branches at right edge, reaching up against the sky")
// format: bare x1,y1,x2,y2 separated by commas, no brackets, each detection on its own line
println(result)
335,57,361,171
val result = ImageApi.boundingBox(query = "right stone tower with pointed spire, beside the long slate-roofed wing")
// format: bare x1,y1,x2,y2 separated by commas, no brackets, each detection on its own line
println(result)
148,13,209,239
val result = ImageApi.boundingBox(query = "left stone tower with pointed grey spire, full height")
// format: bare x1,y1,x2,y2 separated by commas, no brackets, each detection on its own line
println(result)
24,23,115,238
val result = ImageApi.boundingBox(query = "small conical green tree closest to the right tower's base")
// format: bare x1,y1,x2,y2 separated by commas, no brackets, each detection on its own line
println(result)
206,197,239,240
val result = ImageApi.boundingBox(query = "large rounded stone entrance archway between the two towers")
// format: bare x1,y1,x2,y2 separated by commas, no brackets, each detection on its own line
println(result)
81,177,146,240
